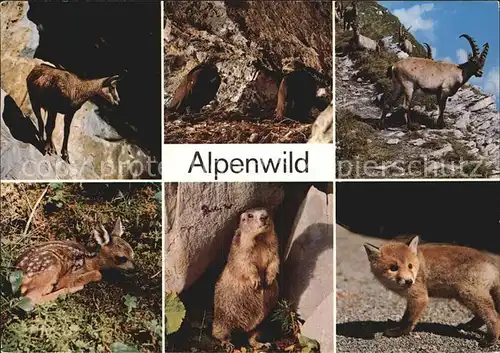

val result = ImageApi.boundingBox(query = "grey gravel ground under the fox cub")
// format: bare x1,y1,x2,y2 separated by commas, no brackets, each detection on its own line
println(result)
336,226,500,353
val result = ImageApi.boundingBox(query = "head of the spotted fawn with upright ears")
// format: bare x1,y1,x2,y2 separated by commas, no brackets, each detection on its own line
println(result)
94,218,134,270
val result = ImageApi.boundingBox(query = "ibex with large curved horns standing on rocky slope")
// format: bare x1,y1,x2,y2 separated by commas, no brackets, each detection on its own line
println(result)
381,34,489,128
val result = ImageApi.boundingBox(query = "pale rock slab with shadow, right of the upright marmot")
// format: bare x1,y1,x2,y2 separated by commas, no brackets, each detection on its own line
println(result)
282,187,334,352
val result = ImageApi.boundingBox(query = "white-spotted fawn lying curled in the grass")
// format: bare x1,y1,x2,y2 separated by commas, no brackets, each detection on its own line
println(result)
16,218,134,304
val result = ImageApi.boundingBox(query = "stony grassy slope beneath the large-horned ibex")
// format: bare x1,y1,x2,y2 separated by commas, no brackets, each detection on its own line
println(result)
335,1,500,178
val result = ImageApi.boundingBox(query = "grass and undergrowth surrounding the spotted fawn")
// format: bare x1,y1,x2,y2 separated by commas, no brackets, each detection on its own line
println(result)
0,183,162,352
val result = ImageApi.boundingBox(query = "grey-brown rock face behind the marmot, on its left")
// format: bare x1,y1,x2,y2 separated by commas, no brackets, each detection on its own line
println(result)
165,183,283,292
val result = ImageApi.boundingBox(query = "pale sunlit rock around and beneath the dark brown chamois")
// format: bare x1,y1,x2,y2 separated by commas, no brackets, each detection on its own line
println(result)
0,1,150,179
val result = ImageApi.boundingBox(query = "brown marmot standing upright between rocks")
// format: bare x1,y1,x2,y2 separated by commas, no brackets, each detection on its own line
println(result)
212,208,280,349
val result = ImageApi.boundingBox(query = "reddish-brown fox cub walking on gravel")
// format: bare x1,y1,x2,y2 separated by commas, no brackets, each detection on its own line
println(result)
364,236,500,346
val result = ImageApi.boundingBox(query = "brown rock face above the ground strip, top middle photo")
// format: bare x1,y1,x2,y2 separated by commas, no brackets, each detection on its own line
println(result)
164,1,332,115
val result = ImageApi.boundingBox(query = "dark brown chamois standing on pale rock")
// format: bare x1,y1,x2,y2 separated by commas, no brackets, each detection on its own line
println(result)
26,63,120,163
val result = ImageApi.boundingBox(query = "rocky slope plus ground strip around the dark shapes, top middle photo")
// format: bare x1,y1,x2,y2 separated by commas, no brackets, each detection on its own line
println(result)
164,1,332,143
